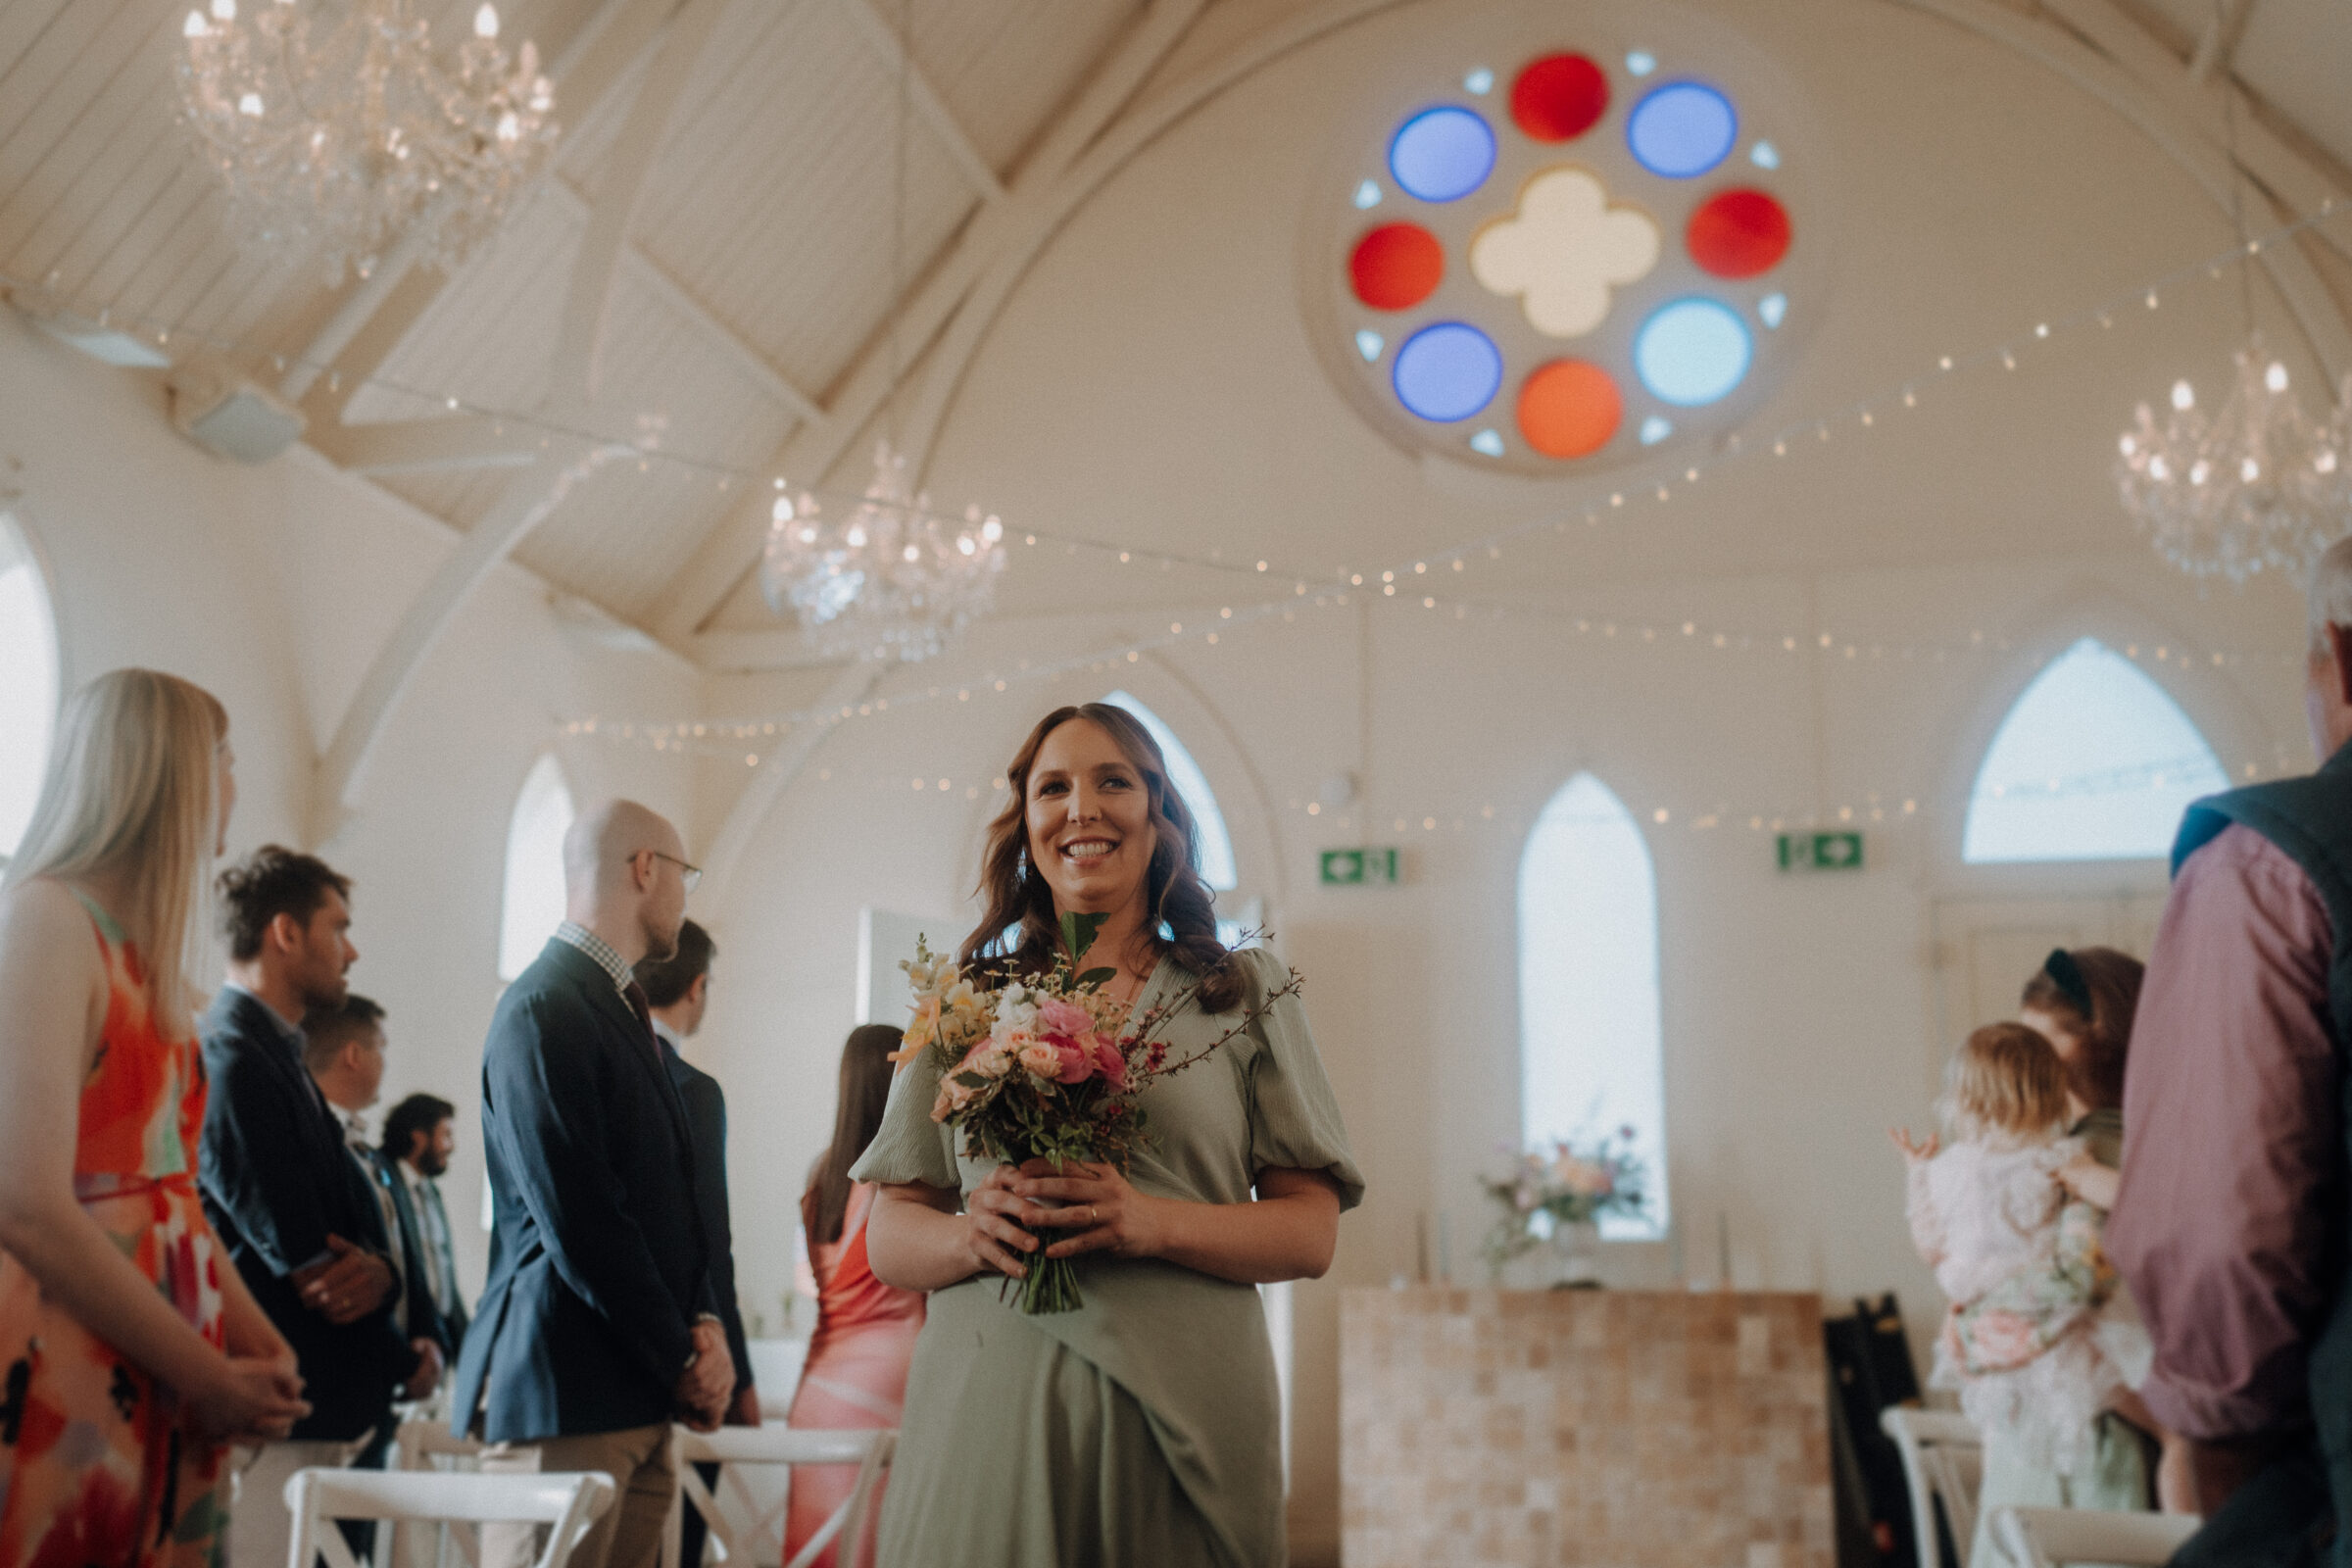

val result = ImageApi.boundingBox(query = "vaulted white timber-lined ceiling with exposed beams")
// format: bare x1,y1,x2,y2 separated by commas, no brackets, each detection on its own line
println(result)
0,0,2352,714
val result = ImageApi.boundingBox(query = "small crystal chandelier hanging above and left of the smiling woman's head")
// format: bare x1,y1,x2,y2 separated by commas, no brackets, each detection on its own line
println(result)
760,440,1004,662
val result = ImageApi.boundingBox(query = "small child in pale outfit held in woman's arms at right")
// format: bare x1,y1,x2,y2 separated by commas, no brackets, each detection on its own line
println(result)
1893,1022,2147,1568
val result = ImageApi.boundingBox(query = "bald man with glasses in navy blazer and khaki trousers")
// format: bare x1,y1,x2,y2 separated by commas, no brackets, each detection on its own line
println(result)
454,802,734,1568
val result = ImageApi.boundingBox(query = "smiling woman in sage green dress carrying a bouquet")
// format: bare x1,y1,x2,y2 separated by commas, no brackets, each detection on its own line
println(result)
852,703,1364,1568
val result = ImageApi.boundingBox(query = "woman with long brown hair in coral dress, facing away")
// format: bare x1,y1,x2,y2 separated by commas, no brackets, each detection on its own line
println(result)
783,1022,922,1568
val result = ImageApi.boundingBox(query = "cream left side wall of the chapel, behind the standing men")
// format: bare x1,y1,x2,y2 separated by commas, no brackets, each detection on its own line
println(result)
0,311,699,1291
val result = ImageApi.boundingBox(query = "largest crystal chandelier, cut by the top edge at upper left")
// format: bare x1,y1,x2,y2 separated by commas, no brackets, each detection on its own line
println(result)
178,0,558,282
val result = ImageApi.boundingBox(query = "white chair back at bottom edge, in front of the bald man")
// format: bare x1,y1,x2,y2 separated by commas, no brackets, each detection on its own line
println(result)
287,1469,613,1568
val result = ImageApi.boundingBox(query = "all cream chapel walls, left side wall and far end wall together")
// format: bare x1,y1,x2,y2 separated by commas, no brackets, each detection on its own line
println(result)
0,0,2319,1563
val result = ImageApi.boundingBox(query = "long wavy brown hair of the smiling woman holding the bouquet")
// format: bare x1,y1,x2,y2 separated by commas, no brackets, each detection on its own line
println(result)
955,703,1242,1013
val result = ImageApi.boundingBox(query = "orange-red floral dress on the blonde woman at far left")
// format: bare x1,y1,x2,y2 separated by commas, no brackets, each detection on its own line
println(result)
0,898,230,1568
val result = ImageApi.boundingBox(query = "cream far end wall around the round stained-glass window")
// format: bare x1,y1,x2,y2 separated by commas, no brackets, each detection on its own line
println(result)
686,2,2319,1561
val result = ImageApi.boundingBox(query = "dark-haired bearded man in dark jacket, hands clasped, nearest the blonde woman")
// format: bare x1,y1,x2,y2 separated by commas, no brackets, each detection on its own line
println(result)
198,859,421,1568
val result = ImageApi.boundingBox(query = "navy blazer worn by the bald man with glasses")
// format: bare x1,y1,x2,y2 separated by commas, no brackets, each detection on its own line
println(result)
454,941,717,1444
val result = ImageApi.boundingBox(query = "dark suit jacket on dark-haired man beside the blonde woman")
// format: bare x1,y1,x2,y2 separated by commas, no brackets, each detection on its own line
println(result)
198,987,416,1441
